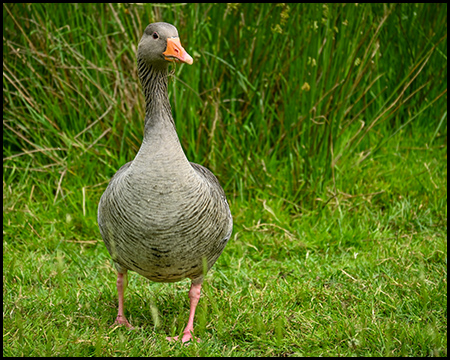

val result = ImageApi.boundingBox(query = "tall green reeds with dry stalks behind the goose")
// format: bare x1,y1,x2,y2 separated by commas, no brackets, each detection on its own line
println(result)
3,3,447,212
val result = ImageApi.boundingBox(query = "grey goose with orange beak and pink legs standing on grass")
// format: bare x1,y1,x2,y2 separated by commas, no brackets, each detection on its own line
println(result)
97,22,233,343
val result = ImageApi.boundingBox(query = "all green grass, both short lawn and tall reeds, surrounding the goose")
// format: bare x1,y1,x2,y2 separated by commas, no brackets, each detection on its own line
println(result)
3,4,447,356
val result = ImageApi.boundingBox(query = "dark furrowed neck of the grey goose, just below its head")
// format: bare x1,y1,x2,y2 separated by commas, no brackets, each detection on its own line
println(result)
138,60,175,137
